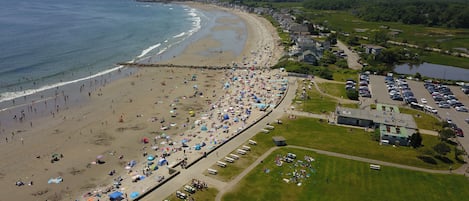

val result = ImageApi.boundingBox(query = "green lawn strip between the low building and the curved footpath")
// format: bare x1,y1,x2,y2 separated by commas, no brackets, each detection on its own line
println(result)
254,118,461,170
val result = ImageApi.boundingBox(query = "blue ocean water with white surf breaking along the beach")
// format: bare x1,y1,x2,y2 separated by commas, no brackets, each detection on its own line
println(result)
0,0,205,103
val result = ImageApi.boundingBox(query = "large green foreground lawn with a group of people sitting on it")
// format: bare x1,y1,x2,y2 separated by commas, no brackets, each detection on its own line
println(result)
223,148,469,201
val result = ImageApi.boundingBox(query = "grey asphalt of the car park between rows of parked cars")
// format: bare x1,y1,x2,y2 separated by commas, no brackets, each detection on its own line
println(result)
362,75,469,151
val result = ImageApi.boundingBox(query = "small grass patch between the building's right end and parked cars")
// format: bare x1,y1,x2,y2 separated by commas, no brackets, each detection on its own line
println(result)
399,107,441,130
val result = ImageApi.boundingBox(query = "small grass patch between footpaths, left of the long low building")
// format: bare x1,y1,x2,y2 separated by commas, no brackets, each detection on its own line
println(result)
293,82,337,114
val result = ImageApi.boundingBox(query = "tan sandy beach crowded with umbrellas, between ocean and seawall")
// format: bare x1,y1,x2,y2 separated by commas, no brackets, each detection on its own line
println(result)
0,3,282,201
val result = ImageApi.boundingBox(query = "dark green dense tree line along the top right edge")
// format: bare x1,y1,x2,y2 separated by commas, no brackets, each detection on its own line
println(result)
303,0,469,28
